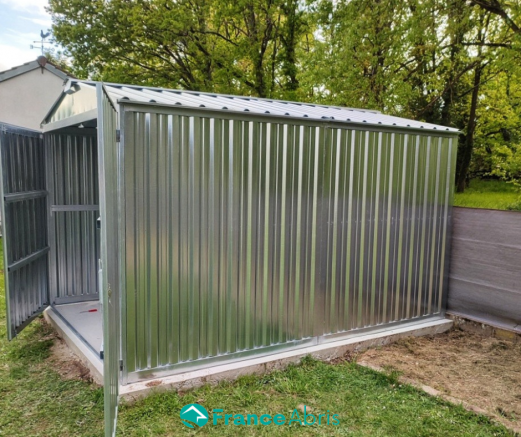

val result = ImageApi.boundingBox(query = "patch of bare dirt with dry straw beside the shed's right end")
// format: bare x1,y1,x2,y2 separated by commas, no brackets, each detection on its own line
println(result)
357,330,521,432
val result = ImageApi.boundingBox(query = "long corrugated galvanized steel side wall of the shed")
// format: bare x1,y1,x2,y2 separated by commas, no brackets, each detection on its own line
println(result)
121,105,455,381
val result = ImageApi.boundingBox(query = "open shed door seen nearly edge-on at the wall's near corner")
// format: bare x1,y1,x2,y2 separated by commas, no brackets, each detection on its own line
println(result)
97,84,121,437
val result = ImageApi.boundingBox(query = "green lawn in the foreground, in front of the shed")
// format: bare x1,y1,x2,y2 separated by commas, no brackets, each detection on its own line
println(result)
0,238,511,437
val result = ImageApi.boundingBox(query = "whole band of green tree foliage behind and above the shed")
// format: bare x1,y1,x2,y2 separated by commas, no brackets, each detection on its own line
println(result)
50,0,521,191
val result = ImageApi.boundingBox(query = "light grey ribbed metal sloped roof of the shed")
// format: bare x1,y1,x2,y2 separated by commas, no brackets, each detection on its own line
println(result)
47,80,458,133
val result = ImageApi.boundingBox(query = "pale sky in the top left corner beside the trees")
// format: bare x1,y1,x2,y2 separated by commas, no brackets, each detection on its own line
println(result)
0,0,52,71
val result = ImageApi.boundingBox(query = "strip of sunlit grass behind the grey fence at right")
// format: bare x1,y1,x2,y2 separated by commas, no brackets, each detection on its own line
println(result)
454,179,521,210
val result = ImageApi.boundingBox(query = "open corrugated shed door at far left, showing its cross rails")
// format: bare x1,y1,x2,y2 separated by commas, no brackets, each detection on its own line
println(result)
0,124,49,340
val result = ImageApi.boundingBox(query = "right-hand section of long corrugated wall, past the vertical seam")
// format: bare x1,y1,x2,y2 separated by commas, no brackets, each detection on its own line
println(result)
317,129,454,334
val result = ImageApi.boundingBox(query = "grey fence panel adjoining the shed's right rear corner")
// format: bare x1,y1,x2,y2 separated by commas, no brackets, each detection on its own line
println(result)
448,208,521,329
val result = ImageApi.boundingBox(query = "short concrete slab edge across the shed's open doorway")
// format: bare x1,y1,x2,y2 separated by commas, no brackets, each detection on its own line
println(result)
43,307,103,385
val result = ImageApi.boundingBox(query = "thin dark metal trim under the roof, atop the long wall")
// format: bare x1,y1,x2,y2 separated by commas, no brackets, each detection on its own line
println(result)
117,99,460,137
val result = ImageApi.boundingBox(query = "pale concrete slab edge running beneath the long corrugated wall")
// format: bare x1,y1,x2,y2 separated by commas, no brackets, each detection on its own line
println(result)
119,319,453,403
